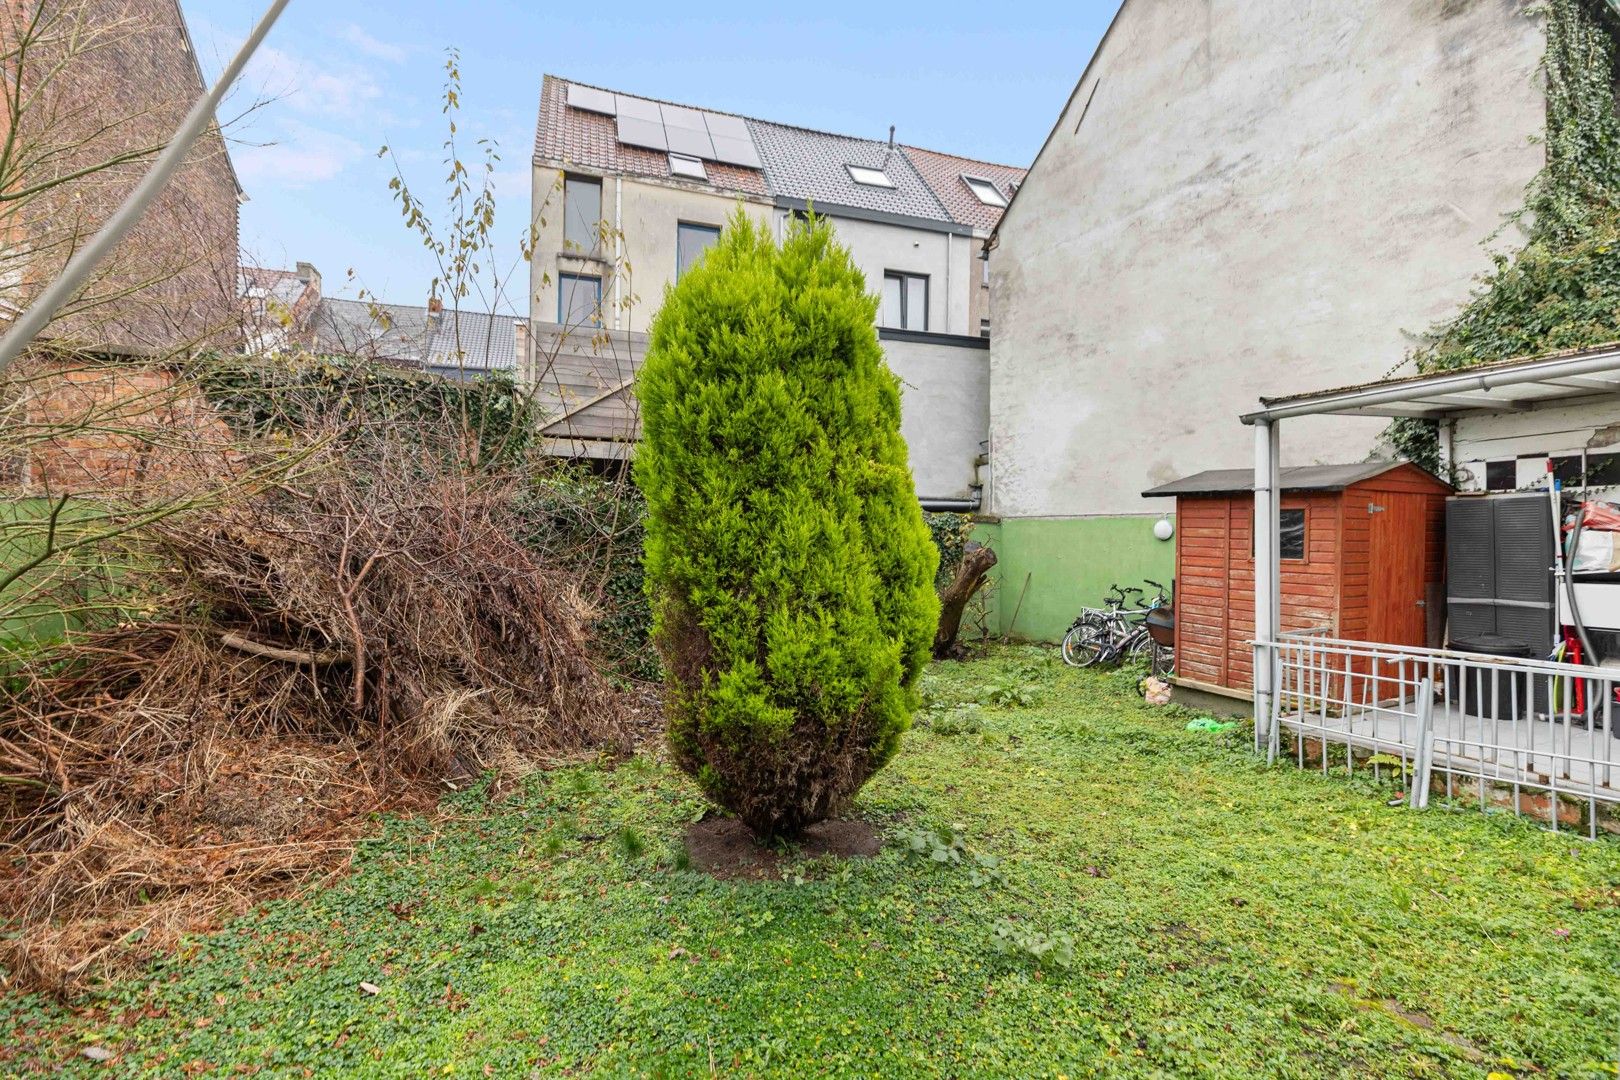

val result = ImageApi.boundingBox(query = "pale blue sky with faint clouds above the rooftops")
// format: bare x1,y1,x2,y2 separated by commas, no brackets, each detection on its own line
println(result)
181,0,1118,317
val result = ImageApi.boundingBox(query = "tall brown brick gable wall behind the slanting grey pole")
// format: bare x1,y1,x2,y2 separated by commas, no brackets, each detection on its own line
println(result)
0,0,240,355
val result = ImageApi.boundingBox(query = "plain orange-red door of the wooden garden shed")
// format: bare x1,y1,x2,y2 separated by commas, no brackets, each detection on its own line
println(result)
1367,491,1427,646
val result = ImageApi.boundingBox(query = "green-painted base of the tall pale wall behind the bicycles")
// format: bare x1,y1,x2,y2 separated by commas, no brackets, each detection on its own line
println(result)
974,517,1176,641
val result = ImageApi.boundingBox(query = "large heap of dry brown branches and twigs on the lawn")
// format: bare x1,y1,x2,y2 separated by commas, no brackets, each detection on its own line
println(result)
0,430,629,991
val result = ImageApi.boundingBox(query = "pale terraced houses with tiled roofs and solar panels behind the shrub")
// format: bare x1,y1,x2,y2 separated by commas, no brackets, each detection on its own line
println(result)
531,74,1022,508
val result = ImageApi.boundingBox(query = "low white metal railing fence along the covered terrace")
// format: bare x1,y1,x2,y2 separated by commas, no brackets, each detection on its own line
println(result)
1254,630,1620,837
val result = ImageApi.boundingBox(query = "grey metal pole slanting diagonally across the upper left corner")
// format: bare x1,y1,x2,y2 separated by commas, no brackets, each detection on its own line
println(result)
0,0,288,371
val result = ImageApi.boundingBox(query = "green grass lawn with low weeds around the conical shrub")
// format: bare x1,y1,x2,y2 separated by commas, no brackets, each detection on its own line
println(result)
9,649,1620,1077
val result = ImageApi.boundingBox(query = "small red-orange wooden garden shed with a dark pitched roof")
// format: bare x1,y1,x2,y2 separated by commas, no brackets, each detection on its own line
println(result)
1142,461,1452,695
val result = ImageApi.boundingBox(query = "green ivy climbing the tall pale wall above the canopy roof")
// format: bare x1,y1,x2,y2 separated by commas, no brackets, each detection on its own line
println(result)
1387,0,1620,471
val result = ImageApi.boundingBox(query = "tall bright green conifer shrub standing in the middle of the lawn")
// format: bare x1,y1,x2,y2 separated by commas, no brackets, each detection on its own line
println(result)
635,212,940,836
